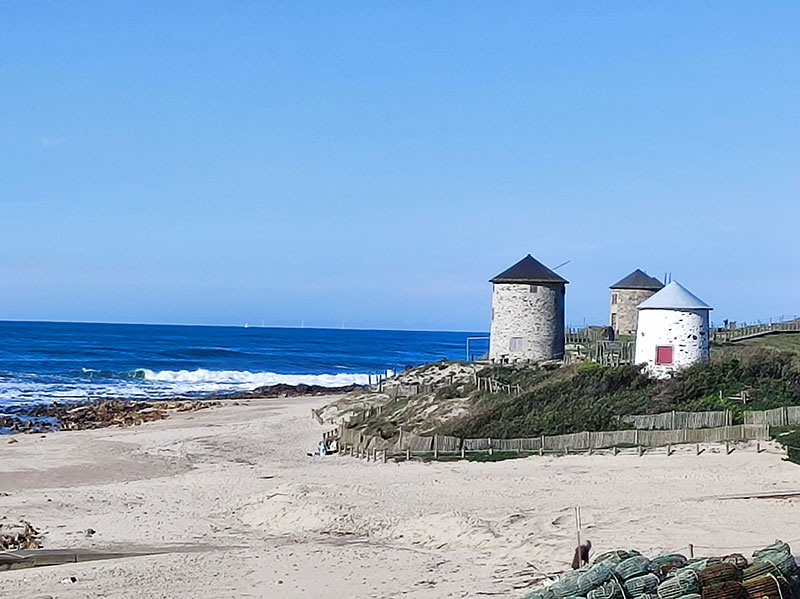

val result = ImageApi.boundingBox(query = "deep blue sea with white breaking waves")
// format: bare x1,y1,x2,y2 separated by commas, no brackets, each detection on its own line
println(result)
0,321,487,405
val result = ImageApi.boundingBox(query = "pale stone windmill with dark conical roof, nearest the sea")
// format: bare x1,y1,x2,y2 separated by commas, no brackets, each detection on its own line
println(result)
489,254,568,363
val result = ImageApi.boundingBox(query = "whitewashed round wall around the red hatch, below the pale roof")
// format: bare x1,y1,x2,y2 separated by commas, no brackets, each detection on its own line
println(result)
635,309,709,378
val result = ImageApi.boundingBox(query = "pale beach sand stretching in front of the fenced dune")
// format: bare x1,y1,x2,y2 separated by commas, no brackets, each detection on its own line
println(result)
0,397,800,599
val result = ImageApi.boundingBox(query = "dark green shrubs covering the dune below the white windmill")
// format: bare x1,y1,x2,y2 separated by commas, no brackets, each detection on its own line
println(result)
440,347,800,438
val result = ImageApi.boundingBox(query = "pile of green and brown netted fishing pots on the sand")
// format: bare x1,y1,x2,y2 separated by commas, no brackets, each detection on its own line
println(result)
525,541,800,599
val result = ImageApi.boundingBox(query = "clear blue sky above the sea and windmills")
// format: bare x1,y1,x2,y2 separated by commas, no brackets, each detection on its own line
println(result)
0,0,800,330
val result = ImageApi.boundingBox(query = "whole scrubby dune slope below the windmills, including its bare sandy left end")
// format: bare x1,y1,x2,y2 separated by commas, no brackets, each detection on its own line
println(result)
346,335,800,438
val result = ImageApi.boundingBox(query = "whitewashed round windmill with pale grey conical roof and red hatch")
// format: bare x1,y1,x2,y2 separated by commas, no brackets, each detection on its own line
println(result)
635,281,712,378
